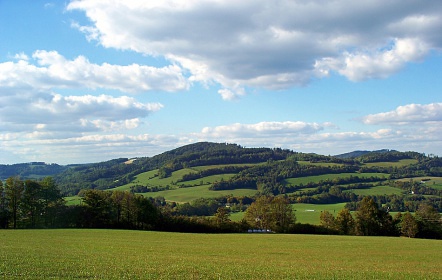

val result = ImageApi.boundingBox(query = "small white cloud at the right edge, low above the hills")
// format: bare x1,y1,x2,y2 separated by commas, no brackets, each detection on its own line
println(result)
362,103,442,125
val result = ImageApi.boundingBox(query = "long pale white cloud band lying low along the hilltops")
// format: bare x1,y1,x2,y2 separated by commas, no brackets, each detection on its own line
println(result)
0,116,442,164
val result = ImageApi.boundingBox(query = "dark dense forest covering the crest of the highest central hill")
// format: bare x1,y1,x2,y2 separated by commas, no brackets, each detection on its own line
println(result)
54,142,295,194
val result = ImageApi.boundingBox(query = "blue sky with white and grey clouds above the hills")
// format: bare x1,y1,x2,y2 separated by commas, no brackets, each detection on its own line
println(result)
0,0,442,164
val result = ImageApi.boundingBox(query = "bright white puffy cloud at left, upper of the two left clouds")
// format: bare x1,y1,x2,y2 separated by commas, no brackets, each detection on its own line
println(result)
0,50,188,92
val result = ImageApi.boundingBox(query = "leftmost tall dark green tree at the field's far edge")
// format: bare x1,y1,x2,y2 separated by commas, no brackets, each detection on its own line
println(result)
5,177,25,229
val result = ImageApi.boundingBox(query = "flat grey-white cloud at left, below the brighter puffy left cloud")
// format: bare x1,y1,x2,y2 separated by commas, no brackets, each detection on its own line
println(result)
0,92,163,135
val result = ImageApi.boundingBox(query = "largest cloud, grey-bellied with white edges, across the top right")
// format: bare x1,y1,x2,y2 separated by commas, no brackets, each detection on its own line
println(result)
67,0,442,96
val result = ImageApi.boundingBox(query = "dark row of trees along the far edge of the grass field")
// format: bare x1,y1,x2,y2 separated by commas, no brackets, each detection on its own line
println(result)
0,177,442,238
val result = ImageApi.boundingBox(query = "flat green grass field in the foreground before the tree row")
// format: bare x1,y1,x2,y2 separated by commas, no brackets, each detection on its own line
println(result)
0,229,442,279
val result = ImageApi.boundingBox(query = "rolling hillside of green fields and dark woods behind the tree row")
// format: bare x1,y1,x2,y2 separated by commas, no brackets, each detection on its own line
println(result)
1,142,442,236
